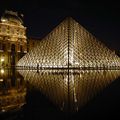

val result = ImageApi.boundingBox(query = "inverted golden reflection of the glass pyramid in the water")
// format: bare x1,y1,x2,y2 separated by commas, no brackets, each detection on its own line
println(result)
19,70,120,112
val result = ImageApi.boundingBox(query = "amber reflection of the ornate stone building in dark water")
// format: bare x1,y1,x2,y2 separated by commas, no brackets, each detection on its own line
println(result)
0,68,26,113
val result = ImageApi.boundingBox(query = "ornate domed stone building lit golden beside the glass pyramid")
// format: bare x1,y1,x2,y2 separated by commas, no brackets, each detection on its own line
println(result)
0,11,27,67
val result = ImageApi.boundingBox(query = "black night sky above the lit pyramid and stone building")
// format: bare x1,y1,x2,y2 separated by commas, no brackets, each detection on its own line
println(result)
0,0,120,50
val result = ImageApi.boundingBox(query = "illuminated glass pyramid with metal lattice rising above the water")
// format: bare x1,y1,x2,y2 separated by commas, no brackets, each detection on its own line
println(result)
17,18,120,69
